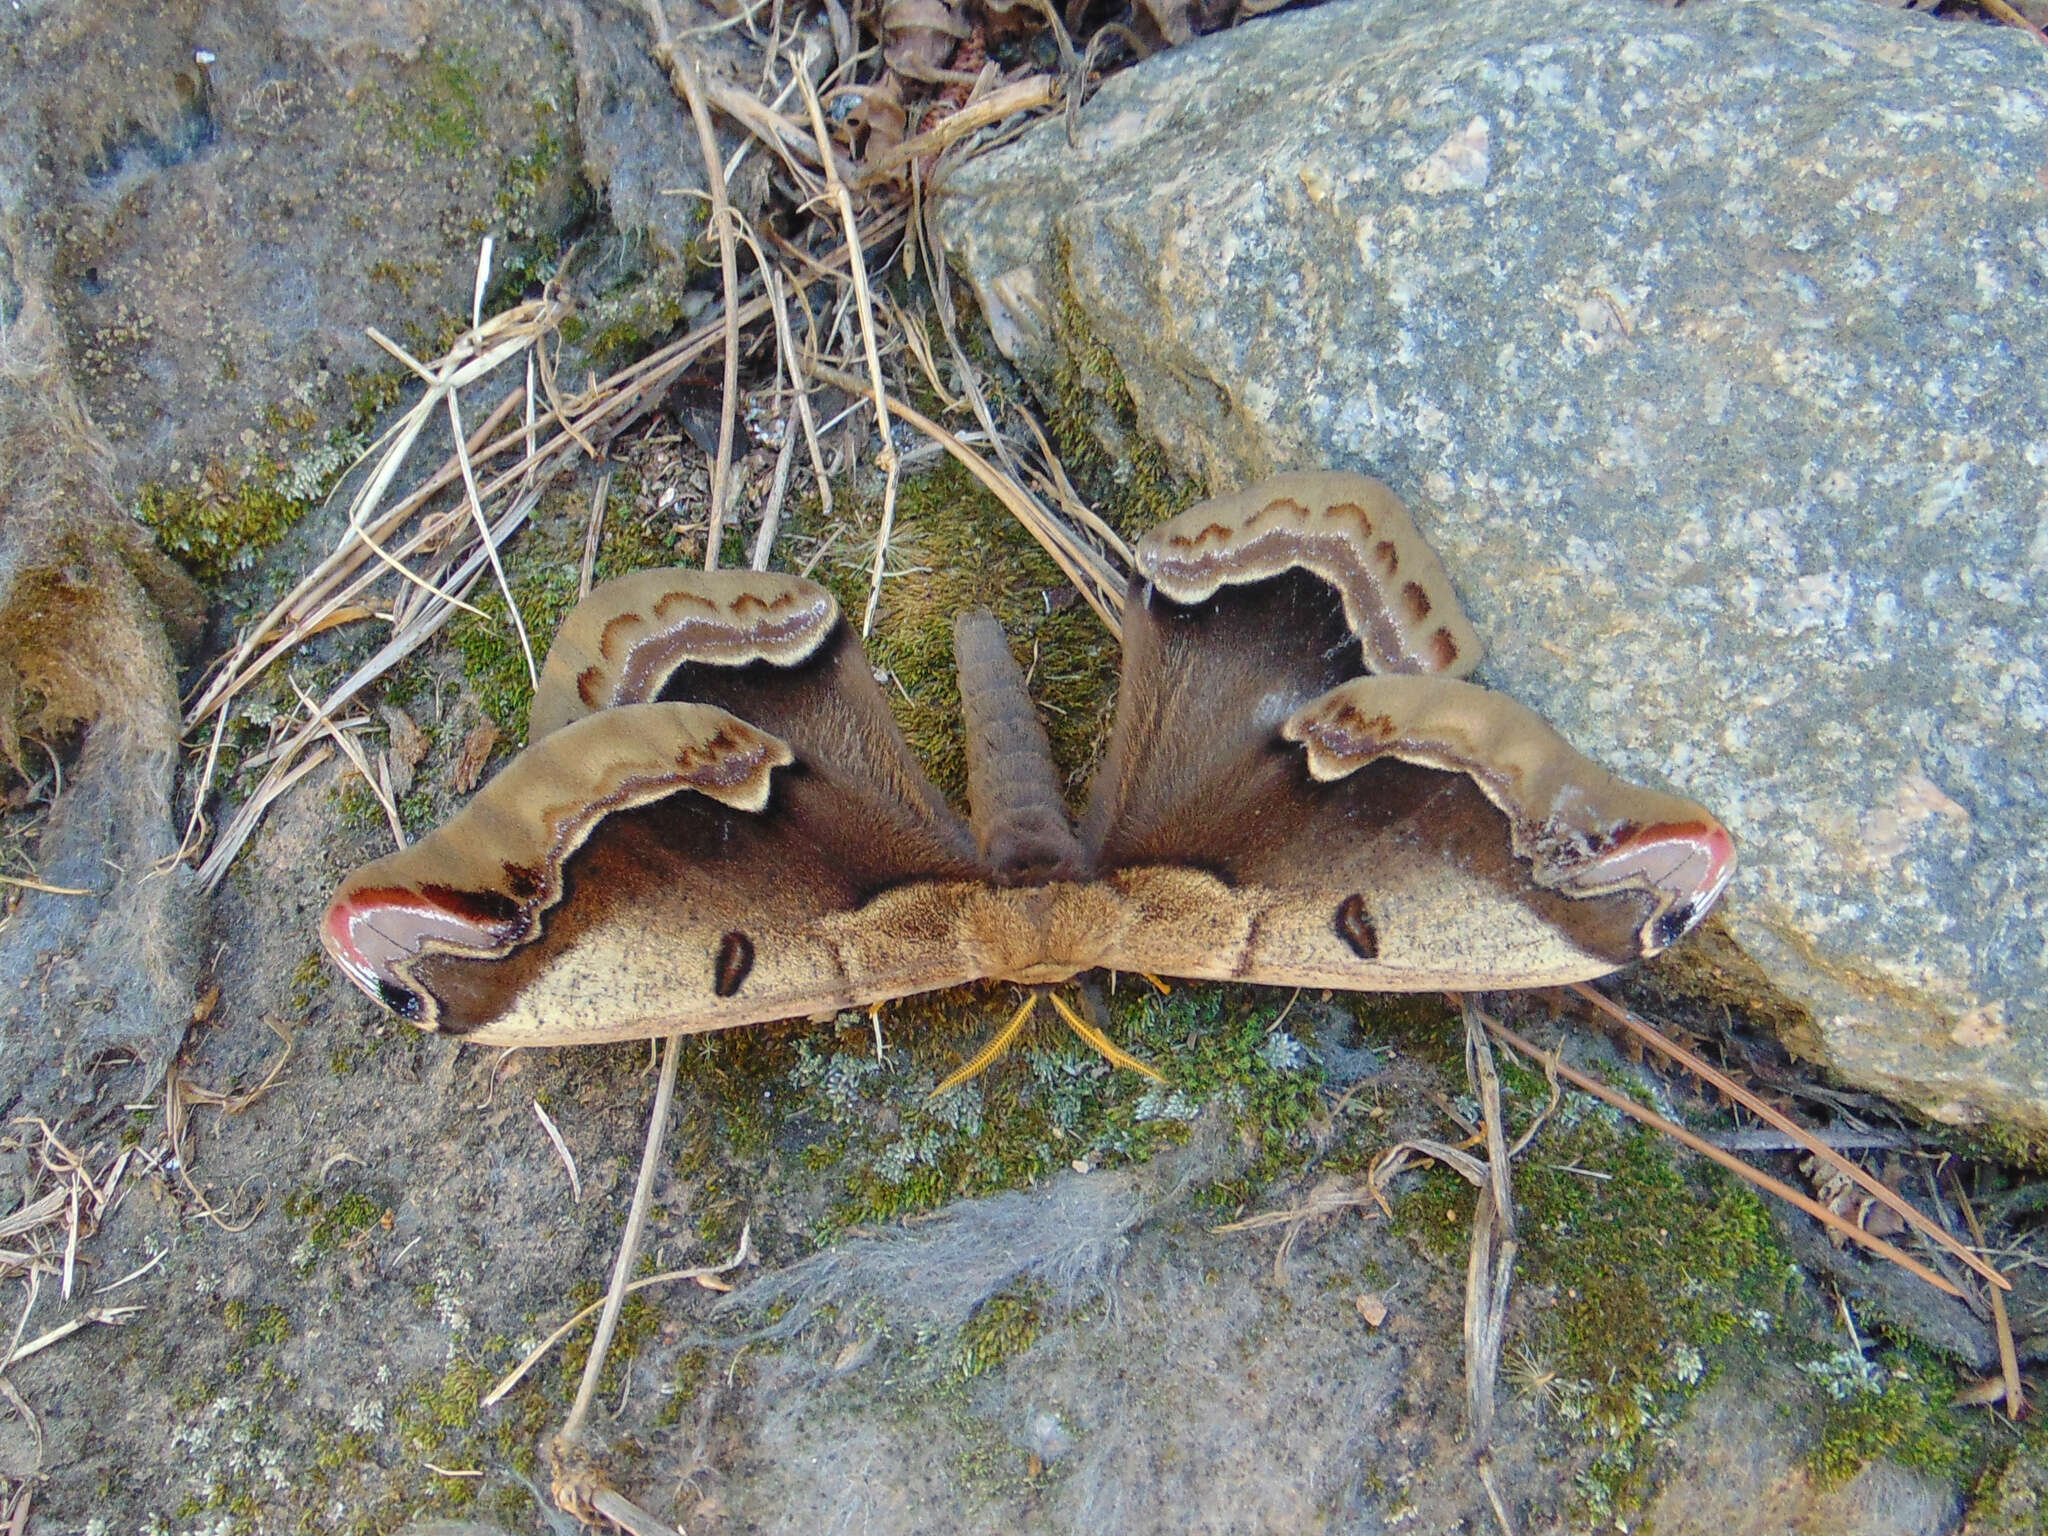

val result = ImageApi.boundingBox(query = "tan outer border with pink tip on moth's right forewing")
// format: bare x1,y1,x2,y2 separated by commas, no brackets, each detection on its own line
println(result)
1280,678,1735,954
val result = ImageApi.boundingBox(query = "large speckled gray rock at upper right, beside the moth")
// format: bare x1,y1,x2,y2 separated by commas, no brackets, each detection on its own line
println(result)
940,0,2048,1130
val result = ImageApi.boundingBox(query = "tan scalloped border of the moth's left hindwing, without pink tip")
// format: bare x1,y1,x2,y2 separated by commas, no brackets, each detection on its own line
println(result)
528,569,840,741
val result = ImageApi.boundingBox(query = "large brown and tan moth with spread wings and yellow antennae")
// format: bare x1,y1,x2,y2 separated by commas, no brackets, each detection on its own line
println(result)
322,473,1735,1073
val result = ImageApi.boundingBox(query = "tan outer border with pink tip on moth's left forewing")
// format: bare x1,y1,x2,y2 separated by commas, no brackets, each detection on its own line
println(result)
322,705,793,1024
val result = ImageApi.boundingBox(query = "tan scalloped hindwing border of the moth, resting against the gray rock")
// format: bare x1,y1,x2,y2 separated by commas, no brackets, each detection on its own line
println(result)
1137,471,1481,678
